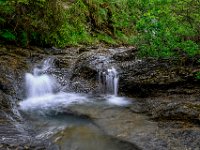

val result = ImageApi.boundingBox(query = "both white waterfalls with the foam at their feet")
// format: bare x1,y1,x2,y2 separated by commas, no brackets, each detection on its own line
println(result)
19,59,129,111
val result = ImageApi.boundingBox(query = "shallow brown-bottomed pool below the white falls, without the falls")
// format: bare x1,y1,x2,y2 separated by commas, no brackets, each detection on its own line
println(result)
20,98,148,150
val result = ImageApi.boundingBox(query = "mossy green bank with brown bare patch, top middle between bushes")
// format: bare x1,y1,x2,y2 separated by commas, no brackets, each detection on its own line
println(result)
44,0,139,47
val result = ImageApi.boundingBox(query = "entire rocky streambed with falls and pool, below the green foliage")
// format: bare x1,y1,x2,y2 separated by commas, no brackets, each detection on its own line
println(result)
0,48,200,150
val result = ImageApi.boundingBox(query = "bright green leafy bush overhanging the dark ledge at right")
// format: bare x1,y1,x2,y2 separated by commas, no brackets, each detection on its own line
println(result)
135,0,200,58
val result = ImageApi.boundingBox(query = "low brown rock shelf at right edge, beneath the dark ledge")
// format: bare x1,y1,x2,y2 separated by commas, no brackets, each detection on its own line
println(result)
142,95,200,124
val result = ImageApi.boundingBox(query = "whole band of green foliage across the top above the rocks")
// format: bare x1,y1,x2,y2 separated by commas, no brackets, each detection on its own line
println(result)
0,0,200,58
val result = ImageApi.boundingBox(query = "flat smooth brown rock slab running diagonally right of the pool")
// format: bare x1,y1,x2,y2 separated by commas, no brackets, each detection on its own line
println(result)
65,103,193,150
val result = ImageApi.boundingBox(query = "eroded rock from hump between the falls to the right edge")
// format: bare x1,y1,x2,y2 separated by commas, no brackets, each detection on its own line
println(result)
67,48,200,149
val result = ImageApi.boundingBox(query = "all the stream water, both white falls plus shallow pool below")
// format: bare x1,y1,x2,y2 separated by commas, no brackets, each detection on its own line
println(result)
19,59,156,150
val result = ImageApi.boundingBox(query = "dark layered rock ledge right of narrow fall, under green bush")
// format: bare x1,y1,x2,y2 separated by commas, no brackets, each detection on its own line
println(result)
119,59,199,97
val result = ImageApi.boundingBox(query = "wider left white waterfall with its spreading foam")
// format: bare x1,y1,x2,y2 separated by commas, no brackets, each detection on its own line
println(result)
19,58,86,111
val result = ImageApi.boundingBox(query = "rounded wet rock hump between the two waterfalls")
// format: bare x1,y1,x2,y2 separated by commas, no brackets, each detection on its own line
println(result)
70,49,110,92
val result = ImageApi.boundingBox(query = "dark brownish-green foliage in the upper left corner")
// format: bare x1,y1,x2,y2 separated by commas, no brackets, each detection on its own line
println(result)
0,0,62,46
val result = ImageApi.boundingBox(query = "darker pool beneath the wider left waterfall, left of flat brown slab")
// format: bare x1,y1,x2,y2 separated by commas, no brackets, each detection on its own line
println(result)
22,97,138,150
